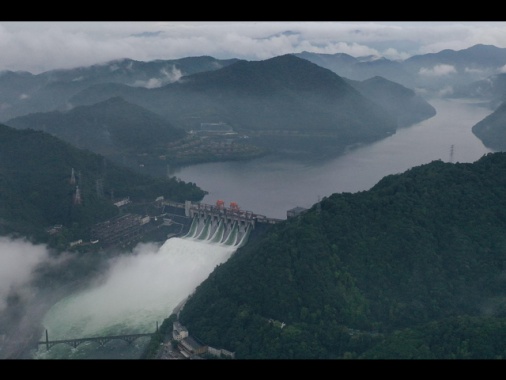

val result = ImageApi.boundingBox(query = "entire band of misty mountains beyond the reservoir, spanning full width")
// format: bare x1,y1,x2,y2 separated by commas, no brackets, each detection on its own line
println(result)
0,45,506,162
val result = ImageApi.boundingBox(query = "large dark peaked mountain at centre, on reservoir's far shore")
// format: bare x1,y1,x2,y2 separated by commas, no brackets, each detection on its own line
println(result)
66,55,397,158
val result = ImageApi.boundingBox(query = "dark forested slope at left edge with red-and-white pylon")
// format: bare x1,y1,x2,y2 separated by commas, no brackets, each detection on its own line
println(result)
0,125,205,245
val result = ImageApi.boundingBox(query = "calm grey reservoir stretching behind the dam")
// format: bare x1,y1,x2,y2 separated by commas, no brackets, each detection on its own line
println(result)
172,99,491,219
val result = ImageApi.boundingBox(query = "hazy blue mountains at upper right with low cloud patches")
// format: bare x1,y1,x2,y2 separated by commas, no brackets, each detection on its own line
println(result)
296,44,506,151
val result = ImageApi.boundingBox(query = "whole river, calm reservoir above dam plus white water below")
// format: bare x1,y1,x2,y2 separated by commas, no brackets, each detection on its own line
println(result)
29,100,491,359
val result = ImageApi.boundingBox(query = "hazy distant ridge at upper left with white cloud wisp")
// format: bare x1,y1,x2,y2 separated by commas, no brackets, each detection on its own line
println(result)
0,56,237,122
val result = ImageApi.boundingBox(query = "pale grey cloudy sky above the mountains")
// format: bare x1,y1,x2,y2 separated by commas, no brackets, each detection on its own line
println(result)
0,21,506,74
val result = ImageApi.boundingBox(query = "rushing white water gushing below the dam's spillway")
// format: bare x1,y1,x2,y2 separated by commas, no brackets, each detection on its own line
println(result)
34,238,237,359
